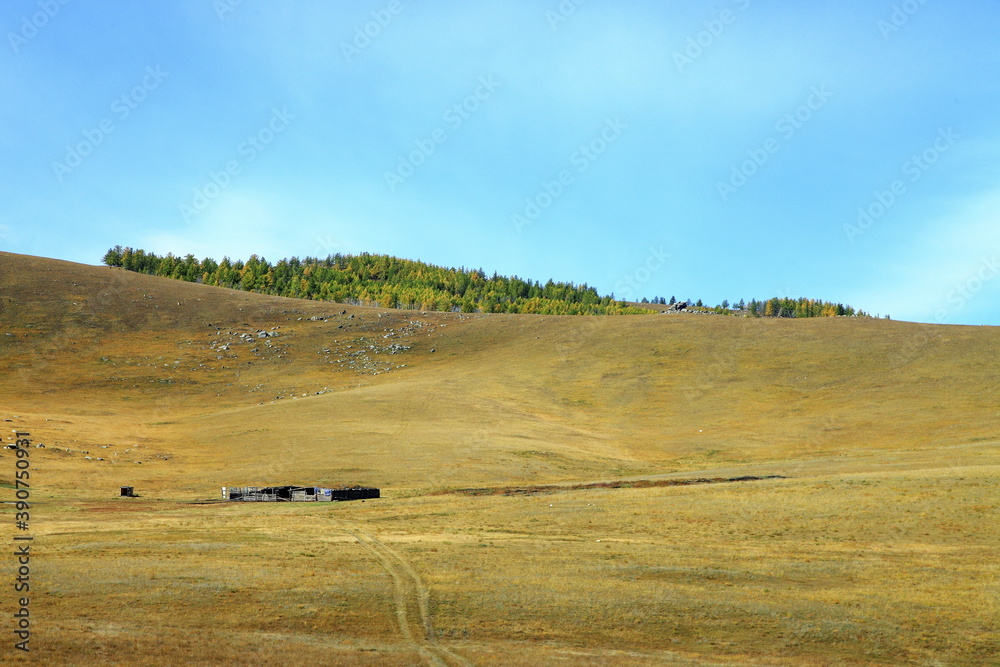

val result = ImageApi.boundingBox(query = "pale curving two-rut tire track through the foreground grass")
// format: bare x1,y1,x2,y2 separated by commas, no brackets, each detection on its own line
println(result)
338,520,471,667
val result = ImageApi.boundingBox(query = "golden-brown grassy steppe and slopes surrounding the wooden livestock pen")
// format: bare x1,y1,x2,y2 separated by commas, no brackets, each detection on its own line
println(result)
0,253,1000,667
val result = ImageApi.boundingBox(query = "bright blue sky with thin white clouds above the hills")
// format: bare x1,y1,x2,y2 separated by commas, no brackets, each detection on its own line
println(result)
0,0,1000,325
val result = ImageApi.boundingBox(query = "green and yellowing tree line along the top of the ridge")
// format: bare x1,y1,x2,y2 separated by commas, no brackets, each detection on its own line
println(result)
97,245,865,317
